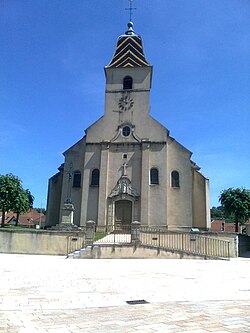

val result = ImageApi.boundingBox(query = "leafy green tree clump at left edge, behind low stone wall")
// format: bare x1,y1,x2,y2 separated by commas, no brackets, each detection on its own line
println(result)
0,173,34,227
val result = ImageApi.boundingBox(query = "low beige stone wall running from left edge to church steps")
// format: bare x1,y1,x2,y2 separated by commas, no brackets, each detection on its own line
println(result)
0,229,85,255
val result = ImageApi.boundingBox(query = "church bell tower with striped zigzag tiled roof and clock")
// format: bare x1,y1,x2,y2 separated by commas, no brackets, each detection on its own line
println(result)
105,21,152,120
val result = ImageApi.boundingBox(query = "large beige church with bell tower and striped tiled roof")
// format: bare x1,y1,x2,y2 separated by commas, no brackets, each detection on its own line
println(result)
46,22,210,231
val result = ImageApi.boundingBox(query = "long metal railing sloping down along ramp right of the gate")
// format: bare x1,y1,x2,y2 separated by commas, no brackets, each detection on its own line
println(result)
140,227,230,259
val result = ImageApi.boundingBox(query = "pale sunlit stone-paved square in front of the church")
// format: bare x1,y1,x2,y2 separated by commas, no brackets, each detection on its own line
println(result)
0,254,250,333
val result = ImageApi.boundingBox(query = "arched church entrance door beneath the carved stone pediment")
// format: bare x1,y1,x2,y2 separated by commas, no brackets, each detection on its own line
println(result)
115,200,132,226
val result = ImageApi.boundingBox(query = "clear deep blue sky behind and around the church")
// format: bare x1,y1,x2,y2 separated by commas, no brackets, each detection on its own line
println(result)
0,0,250,207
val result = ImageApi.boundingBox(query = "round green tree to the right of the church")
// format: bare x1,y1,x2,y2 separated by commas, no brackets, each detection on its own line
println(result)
219,188,250,232
